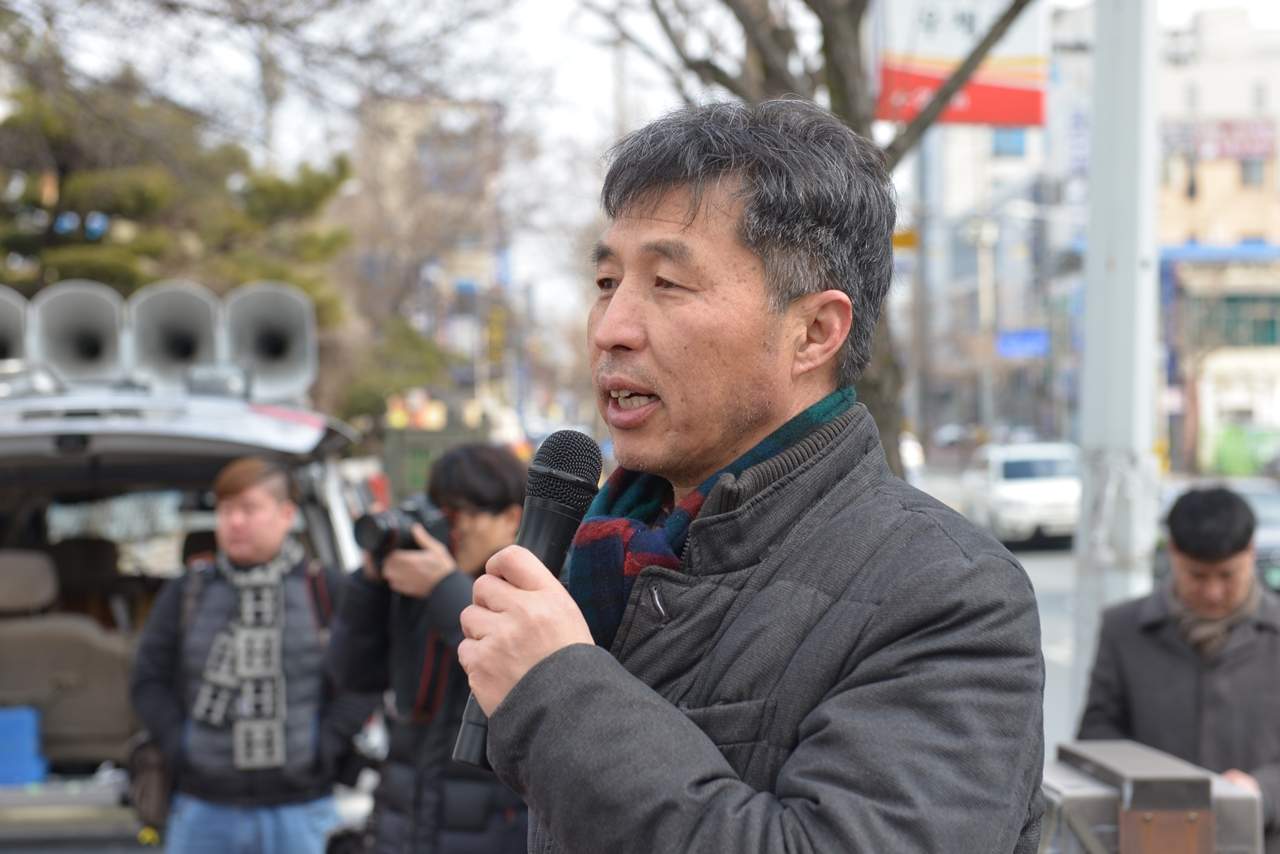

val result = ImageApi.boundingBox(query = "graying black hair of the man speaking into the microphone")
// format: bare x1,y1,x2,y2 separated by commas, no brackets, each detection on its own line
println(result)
600,99,896,385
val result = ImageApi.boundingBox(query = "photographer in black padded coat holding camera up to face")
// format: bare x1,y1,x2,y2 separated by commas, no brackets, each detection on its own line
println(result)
329,444,527,854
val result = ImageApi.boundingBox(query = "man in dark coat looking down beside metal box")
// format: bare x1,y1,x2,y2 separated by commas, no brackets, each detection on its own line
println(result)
1080,489,1280,854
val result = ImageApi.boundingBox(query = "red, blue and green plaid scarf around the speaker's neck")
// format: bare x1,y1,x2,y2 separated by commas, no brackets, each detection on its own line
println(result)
568,388,858,649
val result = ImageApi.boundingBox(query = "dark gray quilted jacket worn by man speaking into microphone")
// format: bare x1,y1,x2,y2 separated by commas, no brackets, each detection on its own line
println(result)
489,406,1044,854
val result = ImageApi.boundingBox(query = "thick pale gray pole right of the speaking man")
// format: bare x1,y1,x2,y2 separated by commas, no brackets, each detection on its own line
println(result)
1071,0,1158,713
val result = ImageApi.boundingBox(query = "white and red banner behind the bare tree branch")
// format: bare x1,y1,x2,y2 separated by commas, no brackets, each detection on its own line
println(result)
876,0,1048,125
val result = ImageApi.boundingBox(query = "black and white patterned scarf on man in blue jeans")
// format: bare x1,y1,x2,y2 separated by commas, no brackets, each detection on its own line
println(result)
191,536,305,771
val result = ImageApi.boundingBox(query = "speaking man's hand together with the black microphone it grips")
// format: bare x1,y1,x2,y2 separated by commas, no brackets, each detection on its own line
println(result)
453,430,602,768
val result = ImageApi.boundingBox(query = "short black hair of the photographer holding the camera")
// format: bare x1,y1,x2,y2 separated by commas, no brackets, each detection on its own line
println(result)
426,444,529,513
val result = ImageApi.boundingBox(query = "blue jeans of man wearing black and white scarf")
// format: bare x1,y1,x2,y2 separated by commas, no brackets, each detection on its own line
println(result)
165,794,338,854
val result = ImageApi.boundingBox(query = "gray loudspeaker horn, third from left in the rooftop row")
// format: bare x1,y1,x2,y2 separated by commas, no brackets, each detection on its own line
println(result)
125,279,223,393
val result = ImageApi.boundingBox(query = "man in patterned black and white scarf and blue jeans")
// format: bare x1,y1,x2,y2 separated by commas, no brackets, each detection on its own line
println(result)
129,457,378,854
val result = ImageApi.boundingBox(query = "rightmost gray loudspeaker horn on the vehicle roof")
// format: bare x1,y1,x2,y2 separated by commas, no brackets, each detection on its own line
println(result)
223,282,316,402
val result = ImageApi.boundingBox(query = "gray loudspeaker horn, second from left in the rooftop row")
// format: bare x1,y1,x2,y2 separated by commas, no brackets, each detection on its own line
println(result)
27,279,124,383
